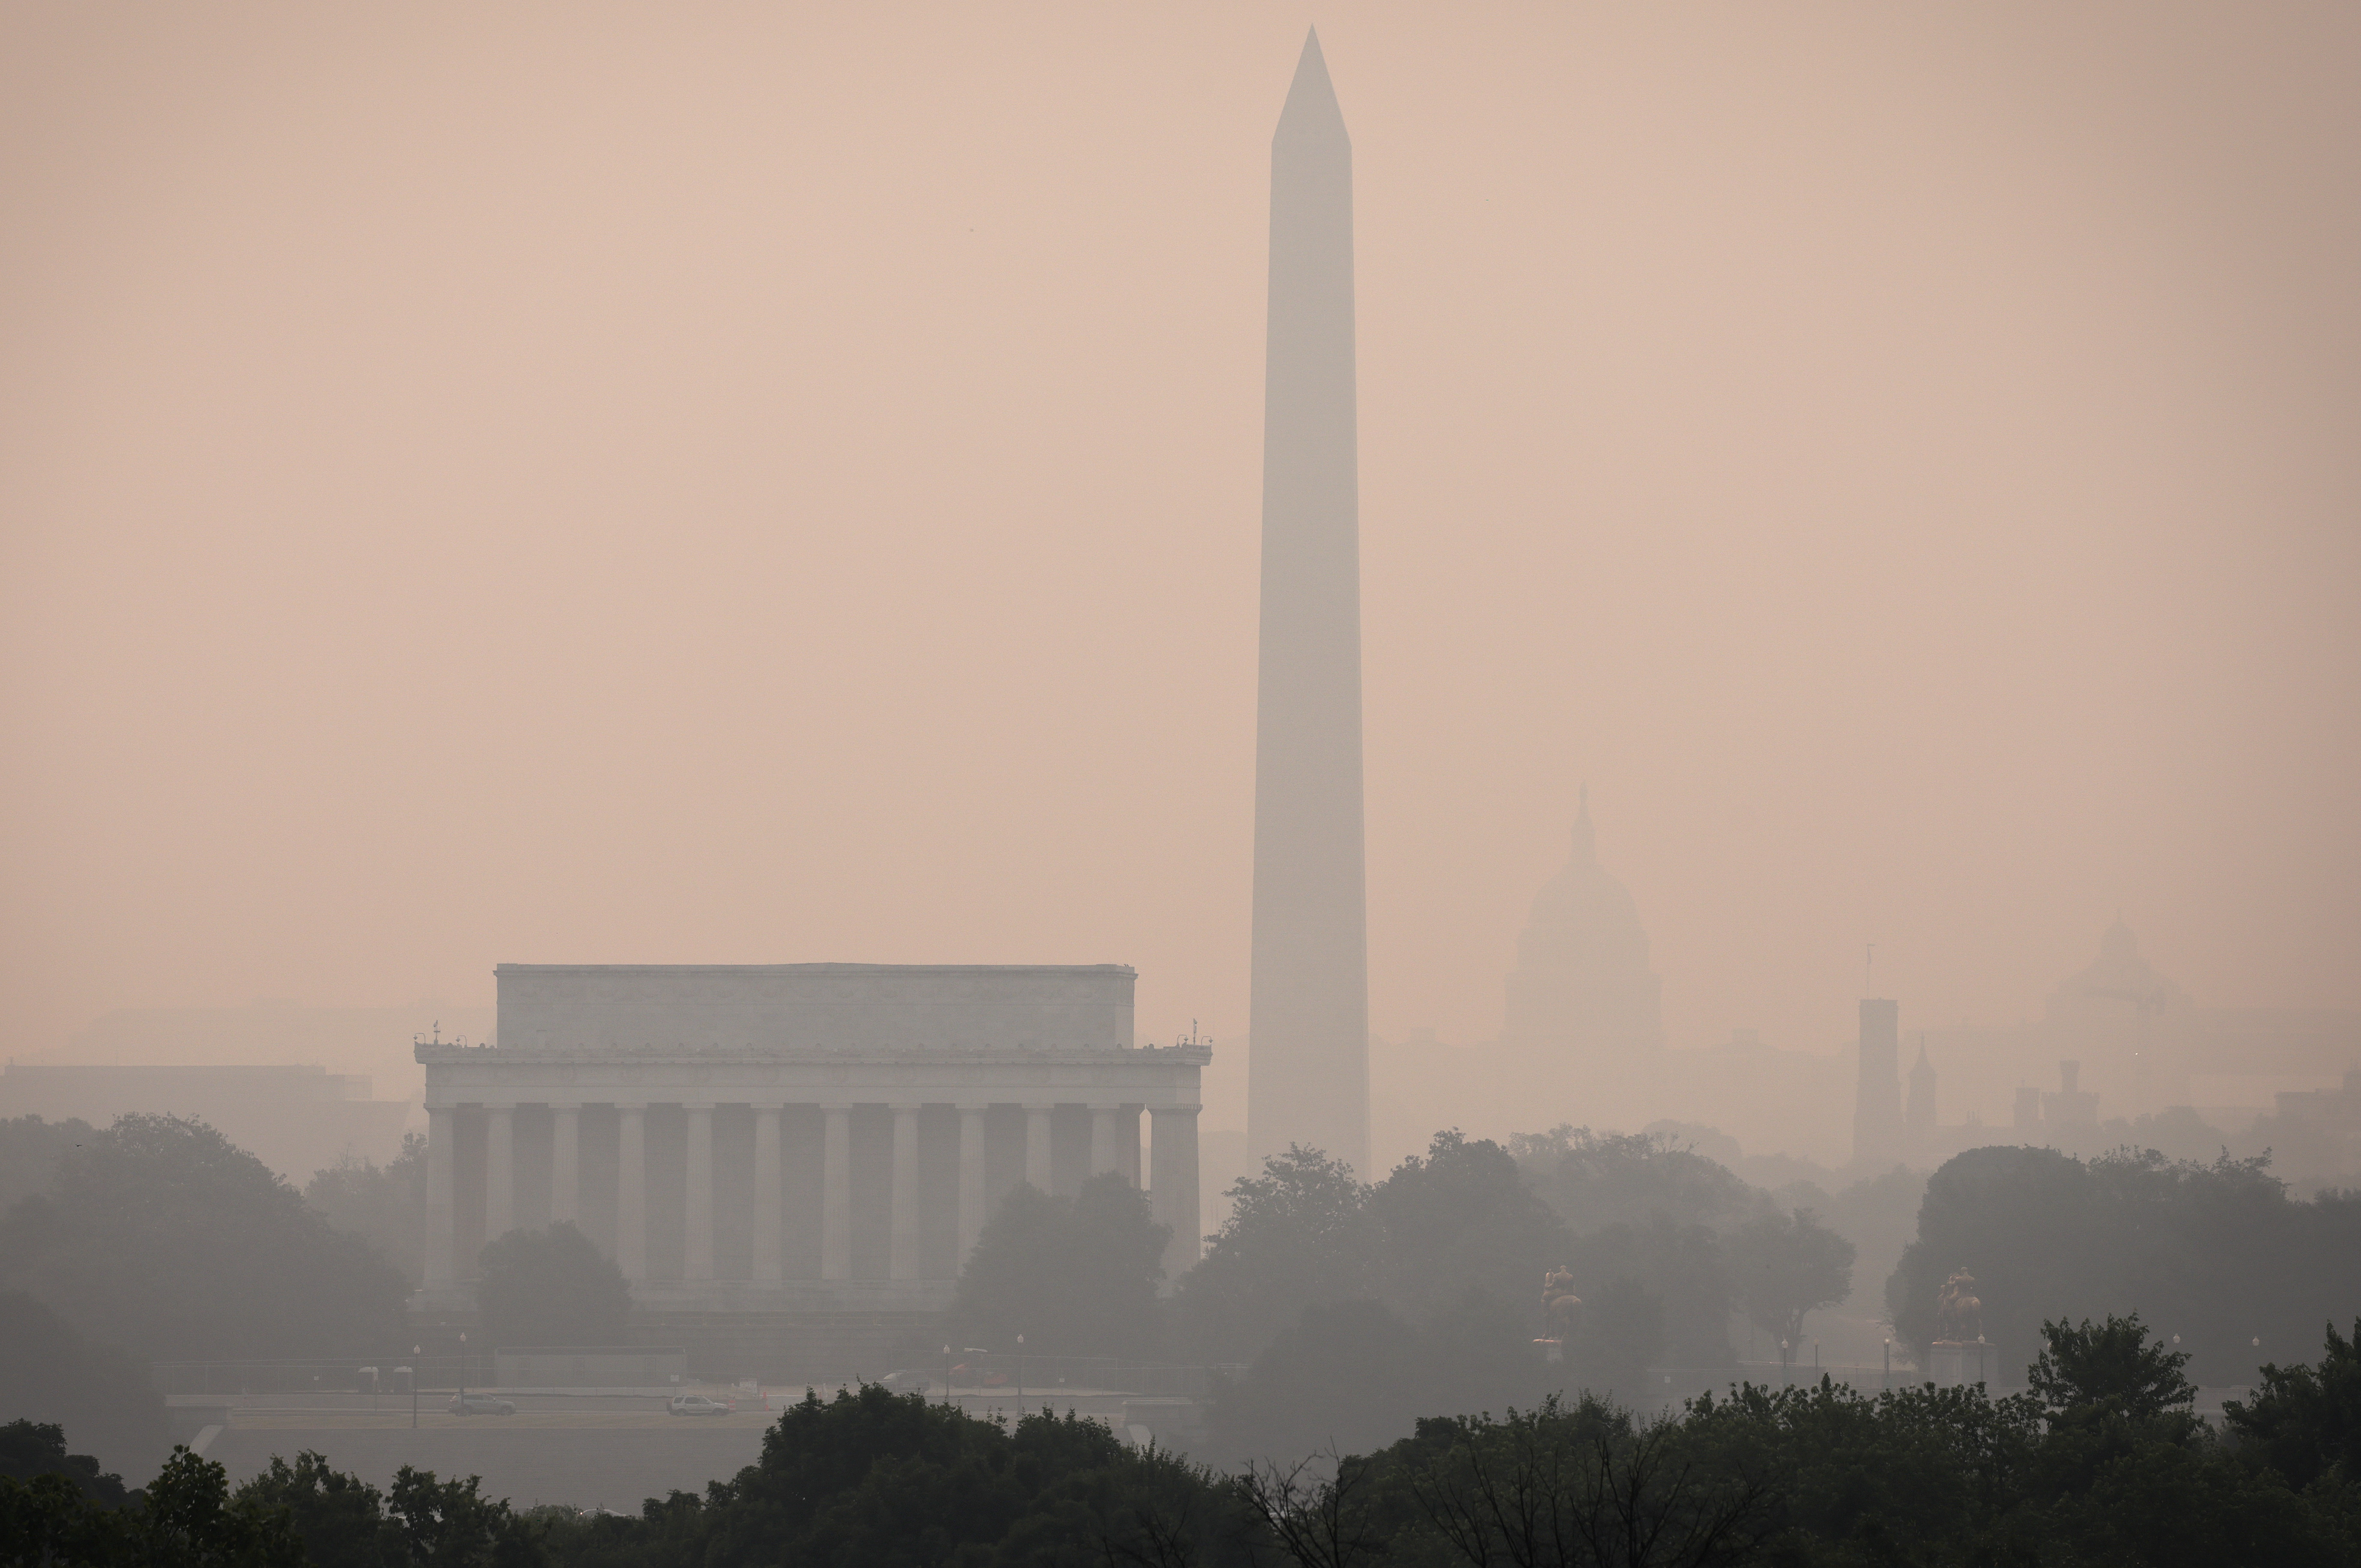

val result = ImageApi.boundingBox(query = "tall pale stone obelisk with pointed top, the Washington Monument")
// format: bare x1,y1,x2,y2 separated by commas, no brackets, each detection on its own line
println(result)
1247,33,1370,1181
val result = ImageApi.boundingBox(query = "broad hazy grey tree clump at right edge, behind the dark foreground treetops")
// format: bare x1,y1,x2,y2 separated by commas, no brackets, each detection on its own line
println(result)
1886,1148,2361,1386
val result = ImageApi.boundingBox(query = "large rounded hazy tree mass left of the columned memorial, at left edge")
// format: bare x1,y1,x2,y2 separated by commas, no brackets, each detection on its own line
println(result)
0,1117,406,1360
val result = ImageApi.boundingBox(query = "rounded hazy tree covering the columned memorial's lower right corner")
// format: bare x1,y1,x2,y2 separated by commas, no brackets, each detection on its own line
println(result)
952,1174,1171,1358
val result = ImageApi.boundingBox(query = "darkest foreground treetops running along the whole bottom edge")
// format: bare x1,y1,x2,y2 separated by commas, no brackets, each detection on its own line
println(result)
14,1318,2361,1568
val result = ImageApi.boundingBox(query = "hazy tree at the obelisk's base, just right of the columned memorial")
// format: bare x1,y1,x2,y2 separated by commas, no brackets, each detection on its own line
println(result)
1173,1145,1381,1360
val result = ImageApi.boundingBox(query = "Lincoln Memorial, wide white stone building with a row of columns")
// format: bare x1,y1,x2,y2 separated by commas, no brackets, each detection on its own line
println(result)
418,963,1211,1315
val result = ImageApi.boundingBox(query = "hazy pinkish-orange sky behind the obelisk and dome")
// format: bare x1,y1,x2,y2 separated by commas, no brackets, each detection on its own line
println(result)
0,3,2361,1127
